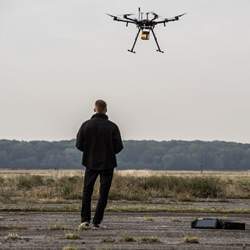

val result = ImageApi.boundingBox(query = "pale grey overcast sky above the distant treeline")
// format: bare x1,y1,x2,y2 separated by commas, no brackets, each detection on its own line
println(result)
0,0,250,142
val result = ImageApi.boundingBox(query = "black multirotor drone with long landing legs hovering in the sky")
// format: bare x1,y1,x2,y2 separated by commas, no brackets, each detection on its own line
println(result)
107,8,186,53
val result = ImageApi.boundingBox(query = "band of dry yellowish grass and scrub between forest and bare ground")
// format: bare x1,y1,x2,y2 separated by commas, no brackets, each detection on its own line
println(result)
0,170,250,203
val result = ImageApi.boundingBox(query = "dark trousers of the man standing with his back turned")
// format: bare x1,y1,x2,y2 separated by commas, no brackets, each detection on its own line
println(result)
81,168,114,224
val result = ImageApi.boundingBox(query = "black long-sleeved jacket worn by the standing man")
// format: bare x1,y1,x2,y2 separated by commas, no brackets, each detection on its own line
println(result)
76,114,123,170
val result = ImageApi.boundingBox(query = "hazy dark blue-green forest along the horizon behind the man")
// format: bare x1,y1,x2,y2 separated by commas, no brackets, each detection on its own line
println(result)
0,140,250,170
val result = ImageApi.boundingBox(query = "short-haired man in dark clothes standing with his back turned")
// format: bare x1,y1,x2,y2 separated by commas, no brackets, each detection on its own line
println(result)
76,100,123,229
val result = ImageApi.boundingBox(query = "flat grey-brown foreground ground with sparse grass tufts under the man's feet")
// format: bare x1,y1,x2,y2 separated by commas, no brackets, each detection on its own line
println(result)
0,212,250,250
